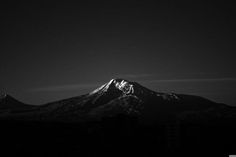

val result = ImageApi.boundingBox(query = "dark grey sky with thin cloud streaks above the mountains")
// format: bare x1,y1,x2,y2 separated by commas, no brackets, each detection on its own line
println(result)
0,0,236,105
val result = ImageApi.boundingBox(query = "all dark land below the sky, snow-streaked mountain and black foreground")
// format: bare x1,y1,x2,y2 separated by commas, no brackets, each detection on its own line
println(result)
0,79,236,156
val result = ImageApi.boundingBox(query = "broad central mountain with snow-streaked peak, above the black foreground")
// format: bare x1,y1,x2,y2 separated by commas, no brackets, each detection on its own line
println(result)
0,79,232,123
